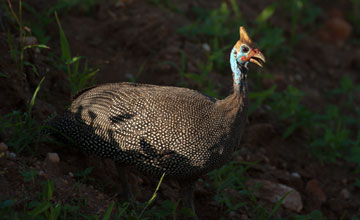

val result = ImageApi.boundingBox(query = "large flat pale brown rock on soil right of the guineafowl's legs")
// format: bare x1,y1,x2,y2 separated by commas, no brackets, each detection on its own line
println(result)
246,179,303,212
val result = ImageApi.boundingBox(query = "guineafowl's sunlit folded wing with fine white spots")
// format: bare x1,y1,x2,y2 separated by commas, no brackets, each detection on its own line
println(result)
71,83,214,153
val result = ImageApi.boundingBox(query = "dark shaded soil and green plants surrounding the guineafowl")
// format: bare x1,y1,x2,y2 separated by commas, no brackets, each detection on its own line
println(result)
0,0,360,220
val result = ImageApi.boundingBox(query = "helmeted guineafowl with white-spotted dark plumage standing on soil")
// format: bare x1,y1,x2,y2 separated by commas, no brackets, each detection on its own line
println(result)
52,27,265,219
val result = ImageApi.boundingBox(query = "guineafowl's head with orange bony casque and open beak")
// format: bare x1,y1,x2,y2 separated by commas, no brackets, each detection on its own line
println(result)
230,26,265,77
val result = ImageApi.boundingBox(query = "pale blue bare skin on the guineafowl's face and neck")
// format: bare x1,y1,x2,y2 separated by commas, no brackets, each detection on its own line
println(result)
230,44,250,85
